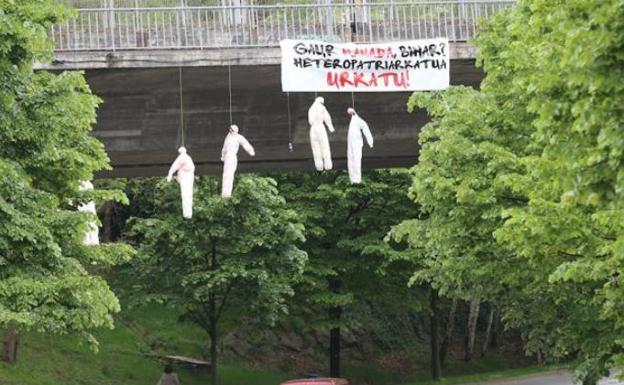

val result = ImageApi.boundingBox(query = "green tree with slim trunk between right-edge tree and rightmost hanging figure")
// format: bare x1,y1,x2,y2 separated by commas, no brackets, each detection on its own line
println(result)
392,87,525,368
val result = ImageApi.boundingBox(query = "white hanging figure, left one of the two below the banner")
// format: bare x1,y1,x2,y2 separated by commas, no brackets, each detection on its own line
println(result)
308,96,334,171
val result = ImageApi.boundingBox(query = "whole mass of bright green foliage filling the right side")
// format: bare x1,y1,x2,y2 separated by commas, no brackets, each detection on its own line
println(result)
395,0,624,384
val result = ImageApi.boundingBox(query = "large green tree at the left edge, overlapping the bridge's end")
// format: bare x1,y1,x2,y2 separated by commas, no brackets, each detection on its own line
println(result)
0,0,131,360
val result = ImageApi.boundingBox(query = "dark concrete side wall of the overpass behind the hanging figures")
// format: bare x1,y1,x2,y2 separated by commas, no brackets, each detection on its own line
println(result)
69,51,482,177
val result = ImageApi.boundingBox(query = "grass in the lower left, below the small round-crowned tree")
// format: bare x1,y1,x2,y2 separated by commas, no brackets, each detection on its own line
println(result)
0,306,285,385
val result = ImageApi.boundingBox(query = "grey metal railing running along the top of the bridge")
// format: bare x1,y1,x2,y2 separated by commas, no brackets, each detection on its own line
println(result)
50,0,515,51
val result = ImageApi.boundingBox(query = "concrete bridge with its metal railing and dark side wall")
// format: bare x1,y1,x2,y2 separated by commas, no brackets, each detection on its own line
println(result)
39,0,513,177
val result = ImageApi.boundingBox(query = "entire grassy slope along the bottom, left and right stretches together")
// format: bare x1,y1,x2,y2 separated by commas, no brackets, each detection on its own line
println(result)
0,306,556,385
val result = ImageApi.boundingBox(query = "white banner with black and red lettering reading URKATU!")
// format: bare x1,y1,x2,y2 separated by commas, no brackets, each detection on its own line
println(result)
280,39,450,92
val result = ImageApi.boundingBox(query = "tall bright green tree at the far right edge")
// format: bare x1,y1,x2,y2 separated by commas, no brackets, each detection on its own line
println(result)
481,0,624,384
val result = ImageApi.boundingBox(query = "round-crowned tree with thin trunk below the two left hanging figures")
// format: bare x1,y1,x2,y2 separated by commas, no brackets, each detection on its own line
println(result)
131,176,307,385
